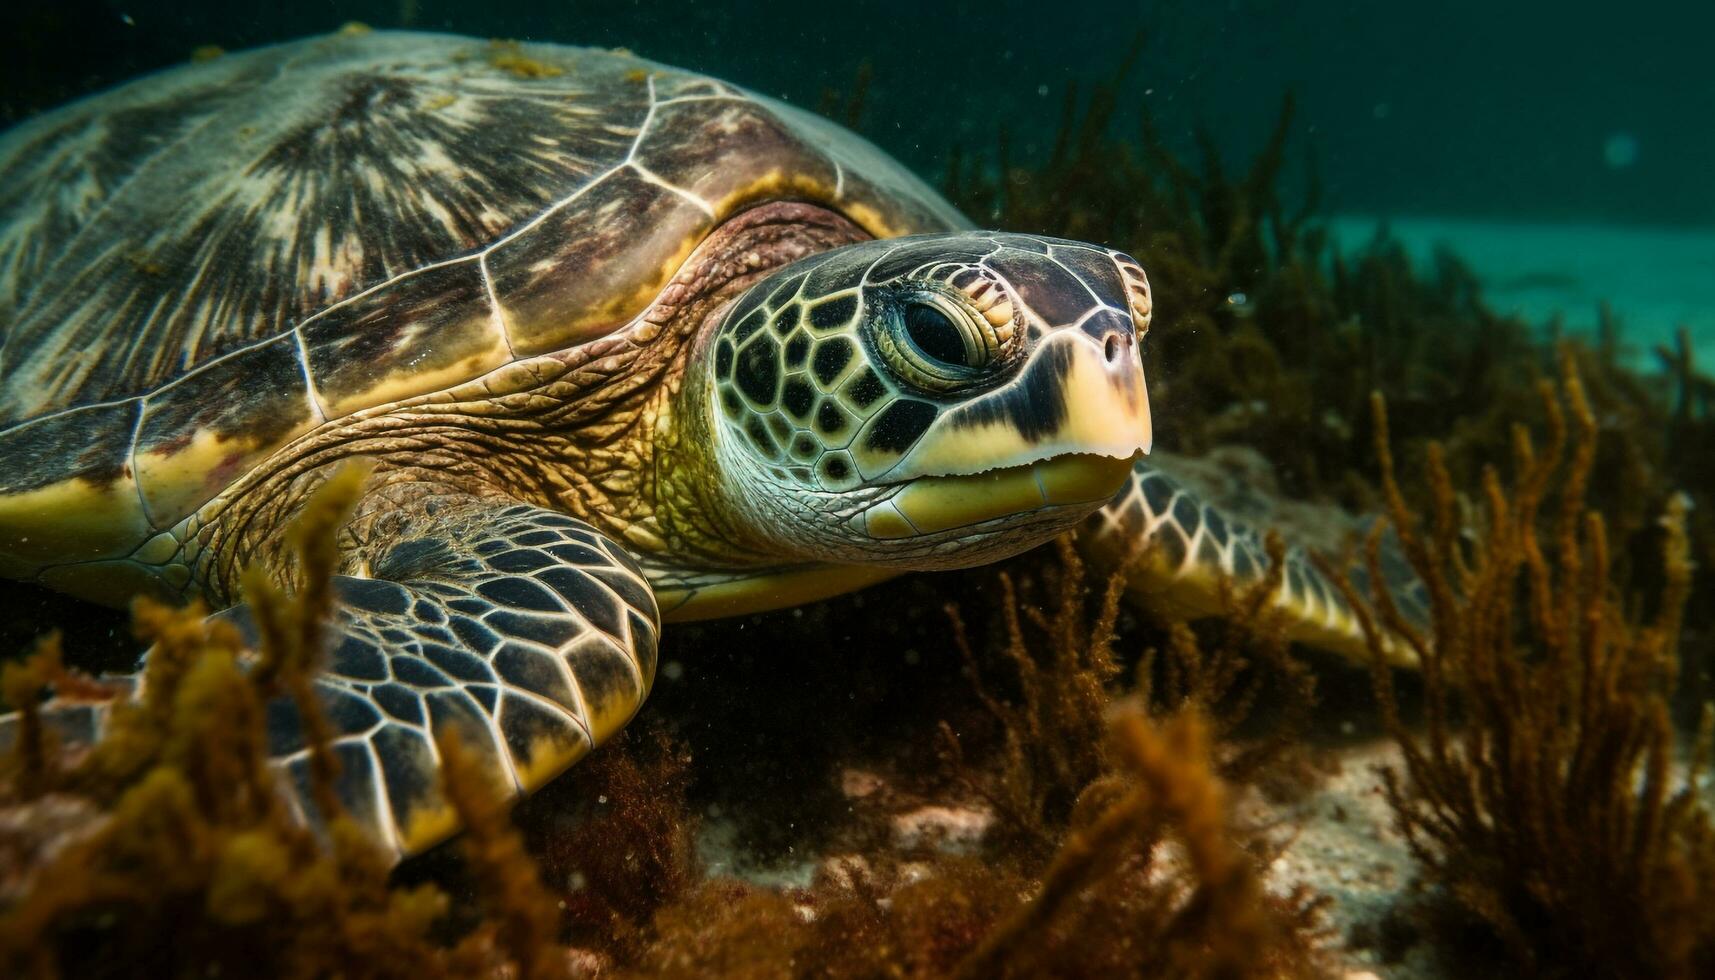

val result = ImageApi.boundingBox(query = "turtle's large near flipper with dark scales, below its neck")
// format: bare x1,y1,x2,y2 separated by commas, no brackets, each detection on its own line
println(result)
218,493,660,855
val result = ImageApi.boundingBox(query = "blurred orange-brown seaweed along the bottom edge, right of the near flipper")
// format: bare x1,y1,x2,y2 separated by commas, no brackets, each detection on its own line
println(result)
619,707,1326,978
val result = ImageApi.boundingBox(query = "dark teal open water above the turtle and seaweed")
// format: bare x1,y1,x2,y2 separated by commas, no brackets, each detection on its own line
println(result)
0,0,1715,225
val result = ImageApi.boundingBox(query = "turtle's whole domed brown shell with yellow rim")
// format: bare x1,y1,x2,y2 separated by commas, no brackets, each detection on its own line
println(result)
0,33,964,590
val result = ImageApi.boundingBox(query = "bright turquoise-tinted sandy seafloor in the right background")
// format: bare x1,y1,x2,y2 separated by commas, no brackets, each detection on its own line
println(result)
1329,215,1715,371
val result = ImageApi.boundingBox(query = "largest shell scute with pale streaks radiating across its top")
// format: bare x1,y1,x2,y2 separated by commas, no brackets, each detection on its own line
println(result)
0,36,648,417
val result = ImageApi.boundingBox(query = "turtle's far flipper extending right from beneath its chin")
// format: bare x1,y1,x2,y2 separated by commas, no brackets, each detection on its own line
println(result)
1080,460,1427,666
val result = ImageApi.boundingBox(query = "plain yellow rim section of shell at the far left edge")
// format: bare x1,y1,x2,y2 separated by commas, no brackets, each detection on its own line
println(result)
0,477,149,578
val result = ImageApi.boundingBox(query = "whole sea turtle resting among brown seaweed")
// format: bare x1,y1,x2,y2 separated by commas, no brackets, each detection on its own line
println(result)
0,31,1406,855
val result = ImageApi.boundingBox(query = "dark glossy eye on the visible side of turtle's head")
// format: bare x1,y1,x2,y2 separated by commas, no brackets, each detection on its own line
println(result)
875,292,1002,391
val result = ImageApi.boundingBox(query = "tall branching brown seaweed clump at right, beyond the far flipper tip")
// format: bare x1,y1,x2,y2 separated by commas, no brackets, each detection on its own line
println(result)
1346,355,1715,977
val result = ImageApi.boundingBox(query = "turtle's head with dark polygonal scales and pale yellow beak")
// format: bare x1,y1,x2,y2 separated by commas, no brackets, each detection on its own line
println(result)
695,232,1151,568
